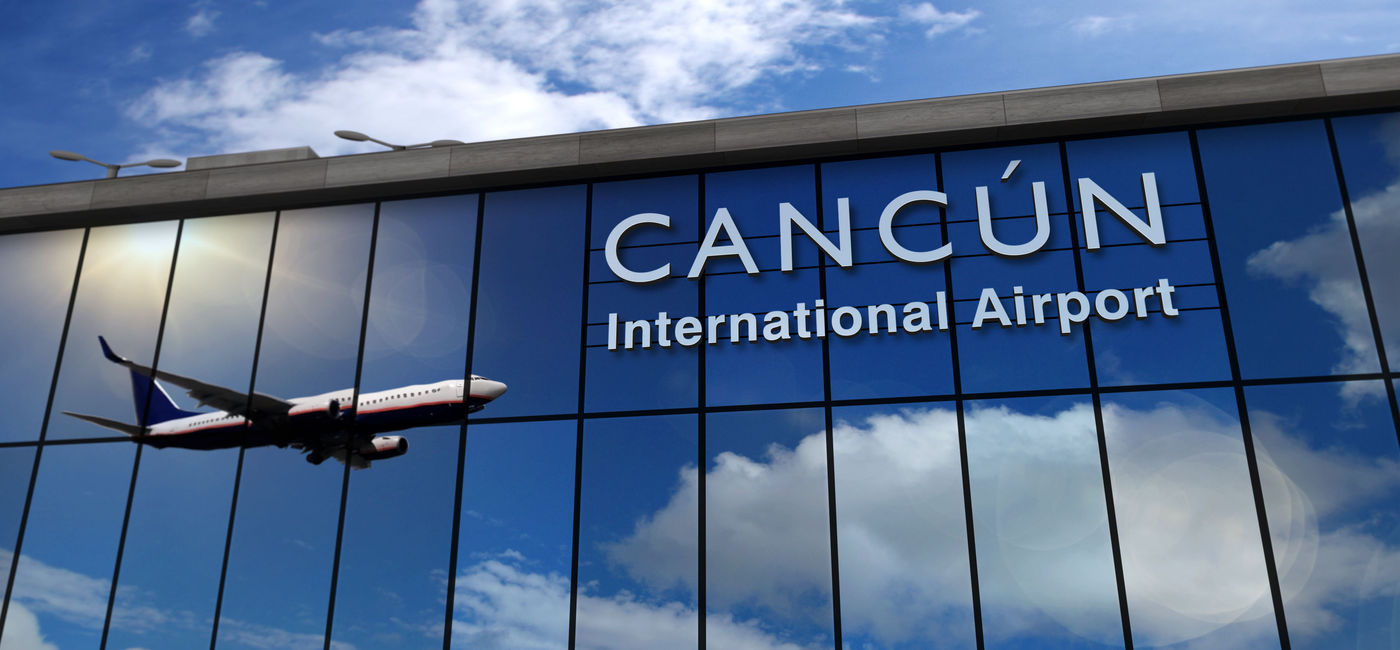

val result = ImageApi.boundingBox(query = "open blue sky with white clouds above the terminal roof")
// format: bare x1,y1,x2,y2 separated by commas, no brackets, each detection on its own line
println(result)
0,0,1400,186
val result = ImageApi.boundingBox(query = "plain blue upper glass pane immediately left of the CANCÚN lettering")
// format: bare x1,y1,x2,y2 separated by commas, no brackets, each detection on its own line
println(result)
472,185,587,416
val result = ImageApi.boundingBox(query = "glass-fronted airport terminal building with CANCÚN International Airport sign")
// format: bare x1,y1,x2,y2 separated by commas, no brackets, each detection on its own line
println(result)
0,55,1400,650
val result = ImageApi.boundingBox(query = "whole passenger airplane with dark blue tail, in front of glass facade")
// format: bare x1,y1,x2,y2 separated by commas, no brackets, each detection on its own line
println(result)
63,336,505,469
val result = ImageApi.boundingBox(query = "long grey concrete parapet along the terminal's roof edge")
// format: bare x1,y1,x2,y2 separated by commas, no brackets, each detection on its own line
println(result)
0,55,1400,233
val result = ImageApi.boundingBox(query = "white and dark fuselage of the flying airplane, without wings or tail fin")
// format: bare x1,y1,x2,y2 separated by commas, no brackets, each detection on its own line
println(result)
134,377,504,450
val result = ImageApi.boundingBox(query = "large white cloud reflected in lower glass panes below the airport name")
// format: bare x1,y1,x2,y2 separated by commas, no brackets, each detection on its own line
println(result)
585,402,1400,646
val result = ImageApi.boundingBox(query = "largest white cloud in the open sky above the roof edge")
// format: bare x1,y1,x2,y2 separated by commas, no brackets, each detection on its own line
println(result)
129,0,876,153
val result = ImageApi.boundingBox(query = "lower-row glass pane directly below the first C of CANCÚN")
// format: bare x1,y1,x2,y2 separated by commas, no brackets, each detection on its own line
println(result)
577,415,697,649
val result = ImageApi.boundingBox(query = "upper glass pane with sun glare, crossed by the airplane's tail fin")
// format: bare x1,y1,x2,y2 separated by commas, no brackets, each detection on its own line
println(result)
46,221,179,440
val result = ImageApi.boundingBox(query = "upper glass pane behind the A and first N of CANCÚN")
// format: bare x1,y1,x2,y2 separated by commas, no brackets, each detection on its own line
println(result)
703,165,823,405
